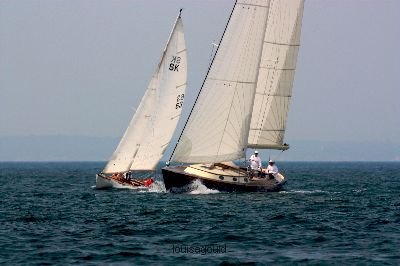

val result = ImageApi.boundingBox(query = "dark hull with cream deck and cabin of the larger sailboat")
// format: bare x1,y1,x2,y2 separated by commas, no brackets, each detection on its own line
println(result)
162,165,285,192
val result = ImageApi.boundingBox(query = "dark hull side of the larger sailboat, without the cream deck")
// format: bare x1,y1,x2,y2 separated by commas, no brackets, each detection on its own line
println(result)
162,166,285,192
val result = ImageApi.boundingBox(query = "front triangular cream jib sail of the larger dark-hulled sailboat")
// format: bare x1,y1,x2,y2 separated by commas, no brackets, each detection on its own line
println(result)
172,0,269,163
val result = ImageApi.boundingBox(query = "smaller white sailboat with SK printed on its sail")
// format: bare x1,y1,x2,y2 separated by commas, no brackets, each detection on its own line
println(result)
96,10,187,188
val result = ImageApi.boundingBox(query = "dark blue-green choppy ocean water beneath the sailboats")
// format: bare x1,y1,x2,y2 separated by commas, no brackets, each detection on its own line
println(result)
0,162,400,265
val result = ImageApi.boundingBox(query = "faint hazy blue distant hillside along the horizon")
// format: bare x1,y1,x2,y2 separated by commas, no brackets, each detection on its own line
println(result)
0,136,400,161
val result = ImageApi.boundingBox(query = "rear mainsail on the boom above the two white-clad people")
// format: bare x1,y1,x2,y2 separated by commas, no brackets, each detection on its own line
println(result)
248,0,304,150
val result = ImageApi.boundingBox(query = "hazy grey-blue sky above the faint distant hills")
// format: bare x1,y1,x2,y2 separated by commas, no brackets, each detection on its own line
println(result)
0,0,400,143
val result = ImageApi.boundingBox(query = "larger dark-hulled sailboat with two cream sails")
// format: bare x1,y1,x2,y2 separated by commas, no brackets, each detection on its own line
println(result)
162,0,304,191
